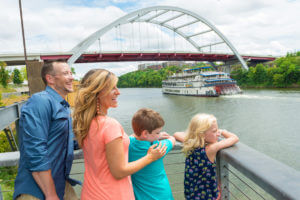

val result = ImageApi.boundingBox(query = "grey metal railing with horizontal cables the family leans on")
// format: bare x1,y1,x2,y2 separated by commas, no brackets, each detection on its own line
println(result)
0,103,300,200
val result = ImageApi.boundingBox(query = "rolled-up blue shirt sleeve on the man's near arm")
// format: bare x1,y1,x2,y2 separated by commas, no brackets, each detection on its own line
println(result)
20,97,51,171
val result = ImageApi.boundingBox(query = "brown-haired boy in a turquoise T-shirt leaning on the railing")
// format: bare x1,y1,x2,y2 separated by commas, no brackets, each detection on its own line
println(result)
129,108,175,200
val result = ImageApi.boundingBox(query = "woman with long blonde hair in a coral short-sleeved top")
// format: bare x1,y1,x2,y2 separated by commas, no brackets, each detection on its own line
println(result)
73,69,166,200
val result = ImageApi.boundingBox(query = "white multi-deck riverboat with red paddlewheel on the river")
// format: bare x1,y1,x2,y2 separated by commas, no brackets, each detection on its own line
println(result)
162,67,242,97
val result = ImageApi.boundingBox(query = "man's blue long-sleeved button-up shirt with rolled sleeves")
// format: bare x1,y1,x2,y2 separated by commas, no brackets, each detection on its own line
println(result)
14,86,74,200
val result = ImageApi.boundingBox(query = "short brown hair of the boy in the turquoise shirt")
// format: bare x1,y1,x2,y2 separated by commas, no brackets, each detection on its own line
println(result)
131,108,165,136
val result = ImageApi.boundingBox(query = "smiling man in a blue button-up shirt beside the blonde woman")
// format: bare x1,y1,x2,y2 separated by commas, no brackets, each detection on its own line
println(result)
13,60,77,200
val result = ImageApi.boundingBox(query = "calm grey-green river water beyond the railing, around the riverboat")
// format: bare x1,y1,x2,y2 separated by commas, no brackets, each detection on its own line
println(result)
109,88,300,171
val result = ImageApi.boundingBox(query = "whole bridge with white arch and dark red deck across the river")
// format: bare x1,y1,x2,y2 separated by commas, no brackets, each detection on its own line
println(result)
0,6,275,69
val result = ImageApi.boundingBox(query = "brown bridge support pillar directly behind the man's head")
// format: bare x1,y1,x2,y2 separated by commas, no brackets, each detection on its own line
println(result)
26,60,45,95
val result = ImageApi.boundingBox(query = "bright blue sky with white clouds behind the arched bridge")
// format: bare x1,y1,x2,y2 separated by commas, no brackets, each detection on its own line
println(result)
0,0,300,78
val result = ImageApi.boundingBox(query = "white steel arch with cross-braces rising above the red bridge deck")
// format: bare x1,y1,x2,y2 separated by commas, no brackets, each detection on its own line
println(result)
68,6,248,70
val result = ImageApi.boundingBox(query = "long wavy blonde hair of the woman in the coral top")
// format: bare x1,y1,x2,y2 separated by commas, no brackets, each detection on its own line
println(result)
73,69,118,146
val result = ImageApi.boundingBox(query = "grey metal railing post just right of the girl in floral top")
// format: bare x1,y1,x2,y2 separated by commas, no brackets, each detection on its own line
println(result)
217,153,230,200
